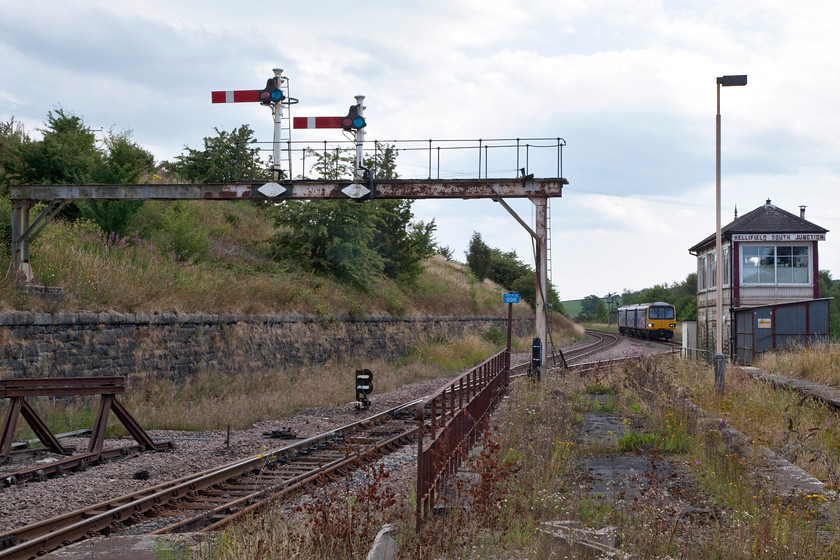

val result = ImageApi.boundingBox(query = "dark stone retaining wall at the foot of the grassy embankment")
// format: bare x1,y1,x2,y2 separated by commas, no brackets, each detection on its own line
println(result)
0,312,534,379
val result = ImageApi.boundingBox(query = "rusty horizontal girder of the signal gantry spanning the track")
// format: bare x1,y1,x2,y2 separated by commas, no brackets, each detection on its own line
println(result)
11,177,568,201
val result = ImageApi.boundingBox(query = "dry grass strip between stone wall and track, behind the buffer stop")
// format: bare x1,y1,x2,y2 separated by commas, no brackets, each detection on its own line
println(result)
17,336,520,439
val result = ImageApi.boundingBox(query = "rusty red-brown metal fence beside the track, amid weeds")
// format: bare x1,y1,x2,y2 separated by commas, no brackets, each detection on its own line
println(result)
417,351,510,531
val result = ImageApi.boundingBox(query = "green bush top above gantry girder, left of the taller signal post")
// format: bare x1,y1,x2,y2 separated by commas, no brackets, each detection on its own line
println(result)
167,124,271,183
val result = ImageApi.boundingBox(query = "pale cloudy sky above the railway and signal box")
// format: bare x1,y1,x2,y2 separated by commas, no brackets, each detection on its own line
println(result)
0,0,840,300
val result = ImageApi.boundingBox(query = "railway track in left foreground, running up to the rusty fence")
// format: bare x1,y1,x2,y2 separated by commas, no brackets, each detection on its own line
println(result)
0,400,420,559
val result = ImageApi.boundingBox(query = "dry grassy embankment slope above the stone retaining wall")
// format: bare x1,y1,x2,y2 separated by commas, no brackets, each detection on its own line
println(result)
0,201,544,317
